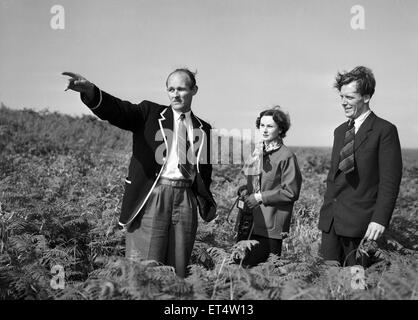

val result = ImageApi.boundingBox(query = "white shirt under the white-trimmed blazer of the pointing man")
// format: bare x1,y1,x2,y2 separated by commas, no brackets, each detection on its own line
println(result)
161,109,196,180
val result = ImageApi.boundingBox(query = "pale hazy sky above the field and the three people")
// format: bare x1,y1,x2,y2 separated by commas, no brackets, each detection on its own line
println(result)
0,0,418,148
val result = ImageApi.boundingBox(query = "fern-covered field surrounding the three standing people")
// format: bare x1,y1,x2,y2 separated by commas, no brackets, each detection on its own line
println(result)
0,106,418,300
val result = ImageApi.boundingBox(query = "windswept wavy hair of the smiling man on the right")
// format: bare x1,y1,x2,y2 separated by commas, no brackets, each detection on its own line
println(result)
334,66,376,97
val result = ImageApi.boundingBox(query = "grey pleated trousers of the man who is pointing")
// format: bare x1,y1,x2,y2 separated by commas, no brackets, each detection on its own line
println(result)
126,180,197,278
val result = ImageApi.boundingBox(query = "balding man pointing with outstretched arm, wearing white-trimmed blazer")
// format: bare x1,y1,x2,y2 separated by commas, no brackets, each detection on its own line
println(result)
63,69,216,277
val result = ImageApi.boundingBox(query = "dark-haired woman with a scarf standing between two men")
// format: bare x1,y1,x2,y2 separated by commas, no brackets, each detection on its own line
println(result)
238,106,302,266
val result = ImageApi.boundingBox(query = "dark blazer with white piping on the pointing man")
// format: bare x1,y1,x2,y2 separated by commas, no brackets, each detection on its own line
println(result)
81,87,216,226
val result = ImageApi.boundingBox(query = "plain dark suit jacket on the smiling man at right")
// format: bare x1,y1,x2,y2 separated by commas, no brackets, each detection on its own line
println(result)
319,112,402,238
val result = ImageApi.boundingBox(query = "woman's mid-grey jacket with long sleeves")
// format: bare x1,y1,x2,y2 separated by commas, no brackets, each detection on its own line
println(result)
247,145,302,239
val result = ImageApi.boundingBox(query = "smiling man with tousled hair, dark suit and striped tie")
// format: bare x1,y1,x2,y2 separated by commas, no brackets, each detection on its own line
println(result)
319,66,402,267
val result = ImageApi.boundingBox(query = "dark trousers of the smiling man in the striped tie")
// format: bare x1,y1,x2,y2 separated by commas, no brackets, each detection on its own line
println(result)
319,221,369,267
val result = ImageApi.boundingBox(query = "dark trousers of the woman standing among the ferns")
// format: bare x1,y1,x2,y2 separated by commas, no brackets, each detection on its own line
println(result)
242,234,282,267
